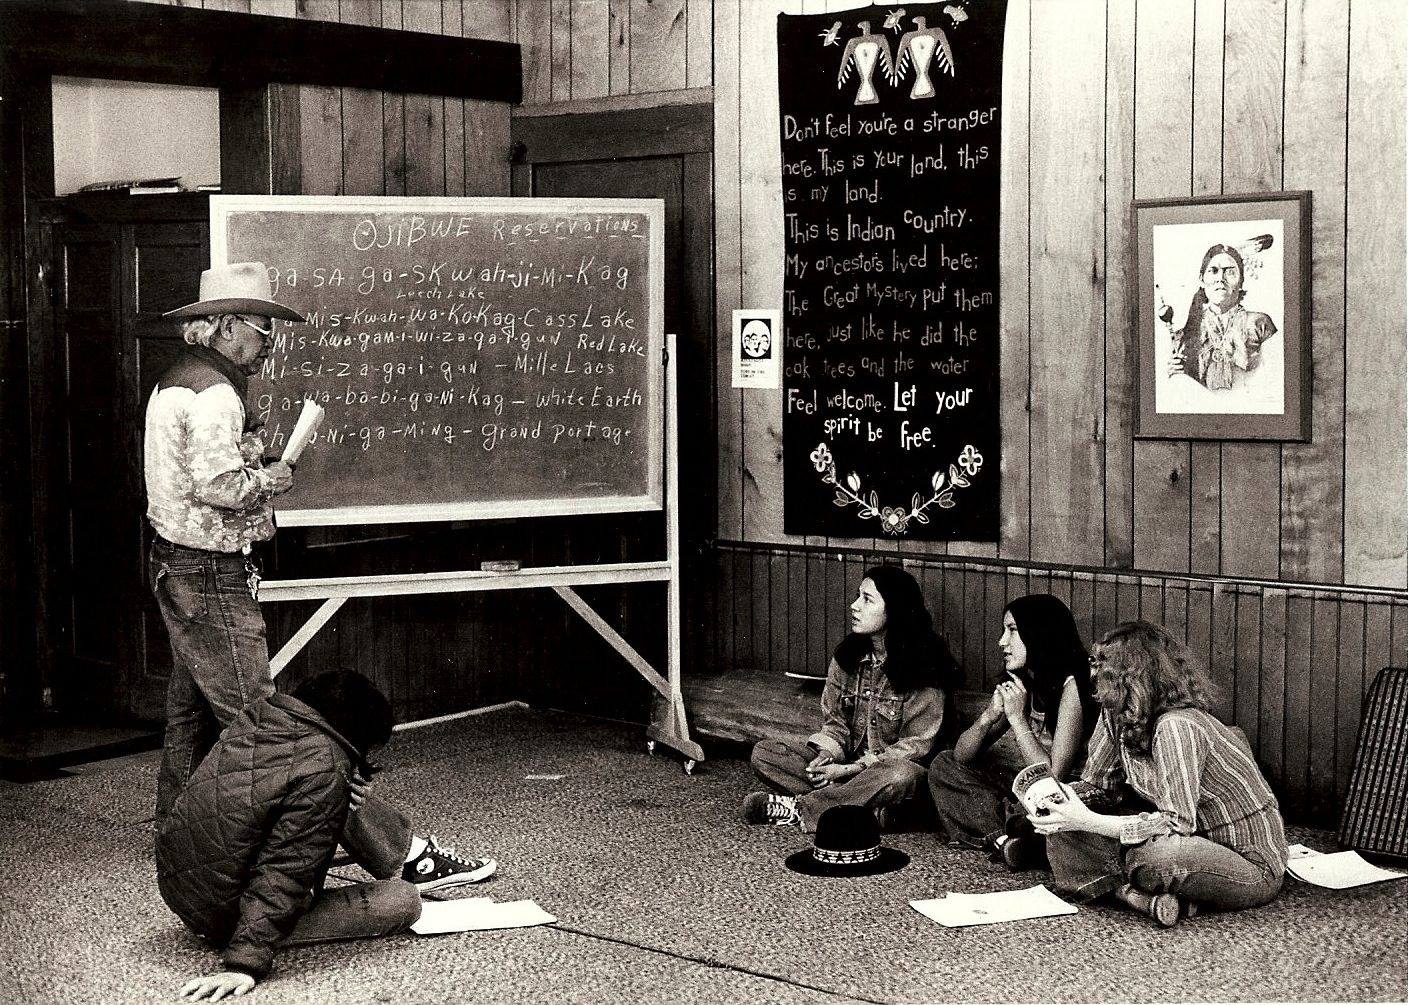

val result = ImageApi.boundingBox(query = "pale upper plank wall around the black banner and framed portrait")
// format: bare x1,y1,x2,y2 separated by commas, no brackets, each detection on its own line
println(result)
714,0,1408,590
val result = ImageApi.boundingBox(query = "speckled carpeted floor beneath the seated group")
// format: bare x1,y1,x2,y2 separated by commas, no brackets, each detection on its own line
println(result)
0,709,1408,1005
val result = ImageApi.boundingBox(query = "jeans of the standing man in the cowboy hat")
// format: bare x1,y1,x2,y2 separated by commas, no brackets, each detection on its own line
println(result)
148,538,275,826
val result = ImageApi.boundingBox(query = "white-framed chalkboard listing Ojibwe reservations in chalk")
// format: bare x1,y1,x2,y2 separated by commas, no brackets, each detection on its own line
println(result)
210,196,665,525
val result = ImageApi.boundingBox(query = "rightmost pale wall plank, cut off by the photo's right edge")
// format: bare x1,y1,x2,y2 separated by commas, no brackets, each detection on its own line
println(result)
1345,0,1408,590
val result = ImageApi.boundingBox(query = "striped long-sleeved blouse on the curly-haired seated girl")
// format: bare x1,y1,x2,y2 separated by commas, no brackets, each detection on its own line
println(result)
1074,708,1287,873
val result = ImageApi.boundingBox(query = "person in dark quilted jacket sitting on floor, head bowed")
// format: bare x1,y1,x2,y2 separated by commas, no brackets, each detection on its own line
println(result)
156,673,496,999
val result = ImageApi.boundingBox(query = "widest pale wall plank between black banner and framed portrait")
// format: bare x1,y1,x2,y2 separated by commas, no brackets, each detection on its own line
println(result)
1029,0,1105,564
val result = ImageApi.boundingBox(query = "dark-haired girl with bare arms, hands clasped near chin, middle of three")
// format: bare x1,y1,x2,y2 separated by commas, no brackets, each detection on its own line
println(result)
929,594,1098,870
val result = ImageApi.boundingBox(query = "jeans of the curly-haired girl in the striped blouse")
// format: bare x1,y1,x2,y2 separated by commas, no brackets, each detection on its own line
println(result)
1046,830,1284,911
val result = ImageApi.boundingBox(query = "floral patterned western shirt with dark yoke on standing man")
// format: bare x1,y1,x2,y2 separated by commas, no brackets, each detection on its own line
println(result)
144,346,275,552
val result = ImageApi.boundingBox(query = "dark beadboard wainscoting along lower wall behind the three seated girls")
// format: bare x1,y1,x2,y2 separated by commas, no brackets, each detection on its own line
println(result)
701,542,1408,826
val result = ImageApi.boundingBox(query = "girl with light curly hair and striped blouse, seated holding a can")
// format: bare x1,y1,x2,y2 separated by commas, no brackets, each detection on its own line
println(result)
1029,621,1287,928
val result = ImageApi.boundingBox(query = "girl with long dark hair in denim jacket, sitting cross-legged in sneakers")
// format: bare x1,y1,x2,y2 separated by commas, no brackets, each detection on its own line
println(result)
743,566,963,832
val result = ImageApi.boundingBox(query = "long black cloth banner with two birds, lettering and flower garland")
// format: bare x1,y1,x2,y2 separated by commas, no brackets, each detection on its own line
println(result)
777,0,1007,541
